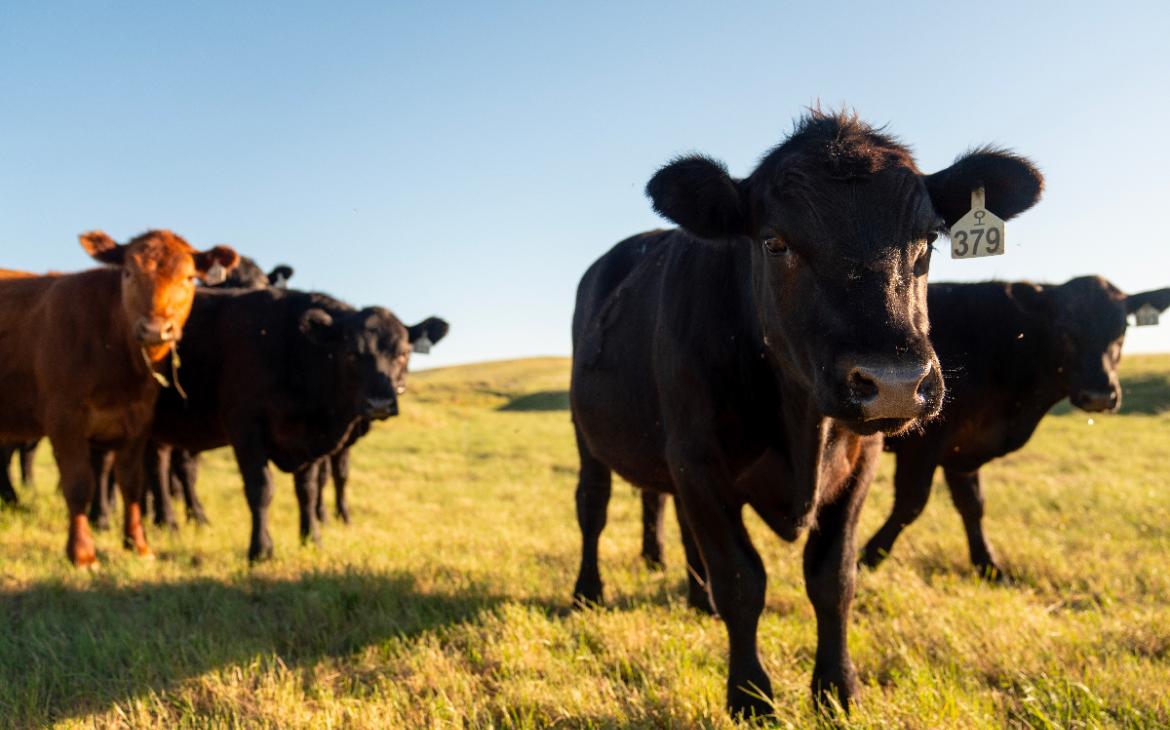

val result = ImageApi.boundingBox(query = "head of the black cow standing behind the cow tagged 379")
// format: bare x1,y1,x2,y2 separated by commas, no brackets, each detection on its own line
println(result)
1011,276,1170,412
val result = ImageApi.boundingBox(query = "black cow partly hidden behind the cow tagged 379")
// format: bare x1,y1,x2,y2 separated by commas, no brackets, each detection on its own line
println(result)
861,276,1170,579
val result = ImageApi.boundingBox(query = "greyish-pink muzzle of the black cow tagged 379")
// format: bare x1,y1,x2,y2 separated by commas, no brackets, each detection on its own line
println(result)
846,360,942,421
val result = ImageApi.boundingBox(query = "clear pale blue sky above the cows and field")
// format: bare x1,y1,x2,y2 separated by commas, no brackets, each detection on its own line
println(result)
0,1,1170,366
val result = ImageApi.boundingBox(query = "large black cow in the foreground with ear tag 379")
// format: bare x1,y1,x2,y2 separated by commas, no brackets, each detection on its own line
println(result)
570,112,1041,714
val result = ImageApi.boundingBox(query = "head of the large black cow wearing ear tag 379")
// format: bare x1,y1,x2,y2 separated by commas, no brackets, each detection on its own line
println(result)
647,113,1041,433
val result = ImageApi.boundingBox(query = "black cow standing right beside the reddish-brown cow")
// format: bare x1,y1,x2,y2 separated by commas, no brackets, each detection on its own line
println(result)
143,289,447,560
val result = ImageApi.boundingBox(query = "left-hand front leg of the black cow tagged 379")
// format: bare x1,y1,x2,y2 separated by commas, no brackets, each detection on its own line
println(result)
667,439,772,717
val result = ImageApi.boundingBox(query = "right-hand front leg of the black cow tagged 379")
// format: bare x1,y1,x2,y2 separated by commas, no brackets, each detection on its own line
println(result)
804,453,878,710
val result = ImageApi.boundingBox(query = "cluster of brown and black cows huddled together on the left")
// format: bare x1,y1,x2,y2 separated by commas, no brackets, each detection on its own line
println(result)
0,230,447,566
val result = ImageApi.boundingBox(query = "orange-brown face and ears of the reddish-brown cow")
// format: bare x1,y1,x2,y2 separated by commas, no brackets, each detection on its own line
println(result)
81,230,240,363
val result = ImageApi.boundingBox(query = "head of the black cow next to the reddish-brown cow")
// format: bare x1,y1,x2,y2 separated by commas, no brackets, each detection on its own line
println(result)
301,307,447,420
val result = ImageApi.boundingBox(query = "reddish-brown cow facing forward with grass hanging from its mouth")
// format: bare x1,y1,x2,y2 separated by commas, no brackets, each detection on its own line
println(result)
0,230,239,565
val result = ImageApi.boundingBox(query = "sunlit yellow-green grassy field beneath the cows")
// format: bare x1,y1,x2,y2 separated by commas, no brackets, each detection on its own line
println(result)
0,357,1170,728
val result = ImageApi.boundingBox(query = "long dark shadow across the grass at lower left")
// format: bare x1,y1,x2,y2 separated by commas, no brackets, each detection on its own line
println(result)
0,572,501,726
